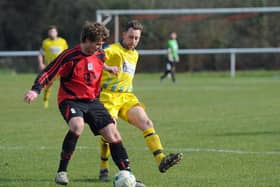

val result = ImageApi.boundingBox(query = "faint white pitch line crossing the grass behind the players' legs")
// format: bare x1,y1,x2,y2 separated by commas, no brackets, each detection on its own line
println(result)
0,145,280,155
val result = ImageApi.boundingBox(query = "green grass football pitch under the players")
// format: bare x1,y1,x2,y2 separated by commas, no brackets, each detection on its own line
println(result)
0,71,280,187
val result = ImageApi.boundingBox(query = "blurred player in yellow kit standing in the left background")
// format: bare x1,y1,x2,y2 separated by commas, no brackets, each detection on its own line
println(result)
38,25,68,108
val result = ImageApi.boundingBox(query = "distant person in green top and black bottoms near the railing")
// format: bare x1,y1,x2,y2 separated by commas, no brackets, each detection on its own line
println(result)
160,32,179,83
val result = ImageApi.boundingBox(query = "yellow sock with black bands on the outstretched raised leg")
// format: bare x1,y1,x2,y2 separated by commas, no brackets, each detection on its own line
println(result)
143,128,165,165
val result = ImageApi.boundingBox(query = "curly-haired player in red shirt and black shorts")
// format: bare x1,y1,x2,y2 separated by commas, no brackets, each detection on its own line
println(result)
24,22,144,185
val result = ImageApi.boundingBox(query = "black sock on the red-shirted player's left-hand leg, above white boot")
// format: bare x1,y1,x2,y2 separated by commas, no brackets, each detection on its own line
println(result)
57,130,79,172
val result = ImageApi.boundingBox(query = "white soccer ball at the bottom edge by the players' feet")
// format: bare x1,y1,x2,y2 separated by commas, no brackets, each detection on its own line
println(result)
113,170,136,187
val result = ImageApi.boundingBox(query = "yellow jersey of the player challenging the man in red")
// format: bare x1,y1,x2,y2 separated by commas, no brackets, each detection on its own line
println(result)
101,43,139,92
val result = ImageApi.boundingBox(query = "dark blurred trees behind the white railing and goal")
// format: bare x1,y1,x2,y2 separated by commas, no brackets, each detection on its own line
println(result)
0,0,280,72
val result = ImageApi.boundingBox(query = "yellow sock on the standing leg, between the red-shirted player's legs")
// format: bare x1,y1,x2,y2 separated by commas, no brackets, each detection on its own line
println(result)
100,137,110,169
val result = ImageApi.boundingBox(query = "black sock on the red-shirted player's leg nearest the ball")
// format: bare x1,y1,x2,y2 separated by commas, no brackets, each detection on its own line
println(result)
109,142,130,171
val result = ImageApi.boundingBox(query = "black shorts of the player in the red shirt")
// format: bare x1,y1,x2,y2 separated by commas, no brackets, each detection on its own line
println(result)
59,98,115,135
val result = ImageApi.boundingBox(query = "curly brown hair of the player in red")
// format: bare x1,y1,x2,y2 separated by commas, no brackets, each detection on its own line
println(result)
80,21,109,42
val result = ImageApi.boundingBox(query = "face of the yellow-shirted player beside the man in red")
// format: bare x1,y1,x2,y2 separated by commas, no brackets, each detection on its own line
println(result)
123,28,141,50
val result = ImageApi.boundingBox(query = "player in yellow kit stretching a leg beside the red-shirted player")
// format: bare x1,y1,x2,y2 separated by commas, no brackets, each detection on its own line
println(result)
99,20,183,181
